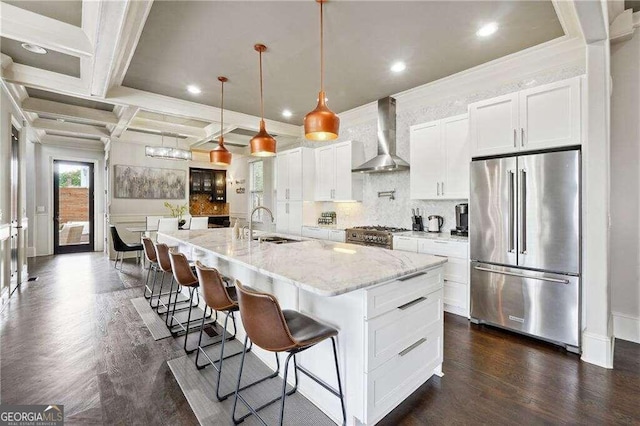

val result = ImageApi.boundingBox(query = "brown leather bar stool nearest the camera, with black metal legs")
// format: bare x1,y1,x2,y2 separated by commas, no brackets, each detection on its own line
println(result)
232,280,347,426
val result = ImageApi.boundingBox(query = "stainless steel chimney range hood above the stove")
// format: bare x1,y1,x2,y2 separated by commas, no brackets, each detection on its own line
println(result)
352,96,409,173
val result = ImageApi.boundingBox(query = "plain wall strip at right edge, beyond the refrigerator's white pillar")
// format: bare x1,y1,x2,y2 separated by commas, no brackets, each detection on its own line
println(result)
610,30,640,343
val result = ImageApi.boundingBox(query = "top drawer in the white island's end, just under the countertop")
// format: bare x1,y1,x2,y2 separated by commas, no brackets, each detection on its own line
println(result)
365,267,443,319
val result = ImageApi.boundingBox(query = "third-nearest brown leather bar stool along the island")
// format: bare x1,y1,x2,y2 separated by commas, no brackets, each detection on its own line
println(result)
169,251,214,354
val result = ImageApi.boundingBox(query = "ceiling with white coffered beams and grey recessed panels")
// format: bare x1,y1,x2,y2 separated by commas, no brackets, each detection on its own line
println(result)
0,0,579,151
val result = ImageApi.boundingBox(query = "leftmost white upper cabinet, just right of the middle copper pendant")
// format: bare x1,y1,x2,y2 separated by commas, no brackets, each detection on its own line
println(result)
276,148,315,201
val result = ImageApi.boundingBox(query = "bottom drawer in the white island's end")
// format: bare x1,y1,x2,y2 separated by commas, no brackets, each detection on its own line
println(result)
364,327,443,424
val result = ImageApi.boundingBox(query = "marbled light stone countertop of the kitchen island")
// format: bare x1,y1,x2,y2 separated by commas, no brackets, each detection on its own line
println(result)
158,228,446,296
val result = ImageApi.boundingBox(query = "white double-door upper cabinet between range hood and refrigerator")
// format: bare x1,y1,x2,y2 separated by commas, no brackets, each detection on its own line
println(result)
409,114,471,200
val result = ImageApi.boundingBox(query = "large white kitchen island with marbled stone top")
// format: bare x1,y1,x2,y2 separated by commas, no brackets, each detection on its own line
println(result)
158,229,446,425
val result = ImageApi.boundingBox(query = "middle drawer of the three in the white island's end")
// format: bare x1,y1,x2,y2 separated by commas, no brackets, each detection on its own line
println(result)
365,289,443,372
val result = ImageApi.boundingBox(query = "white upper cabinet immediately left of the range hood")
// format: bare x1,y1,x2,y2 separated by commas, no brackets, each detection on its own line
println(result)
315,141,364,201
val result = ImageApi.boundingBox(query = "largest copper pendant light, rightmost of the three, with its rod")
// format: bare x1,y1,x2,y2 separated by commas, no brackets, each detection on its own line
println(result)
304,0,340,141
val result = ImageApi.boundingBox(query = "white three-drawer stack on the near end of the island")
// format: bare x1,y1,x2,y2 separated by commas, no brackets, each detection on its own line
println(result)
364,274,444,424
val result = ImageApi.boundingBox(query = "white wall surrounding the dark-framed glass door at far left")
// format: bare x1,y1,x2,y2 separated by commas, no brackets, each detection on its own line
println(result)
28,144,105,256
